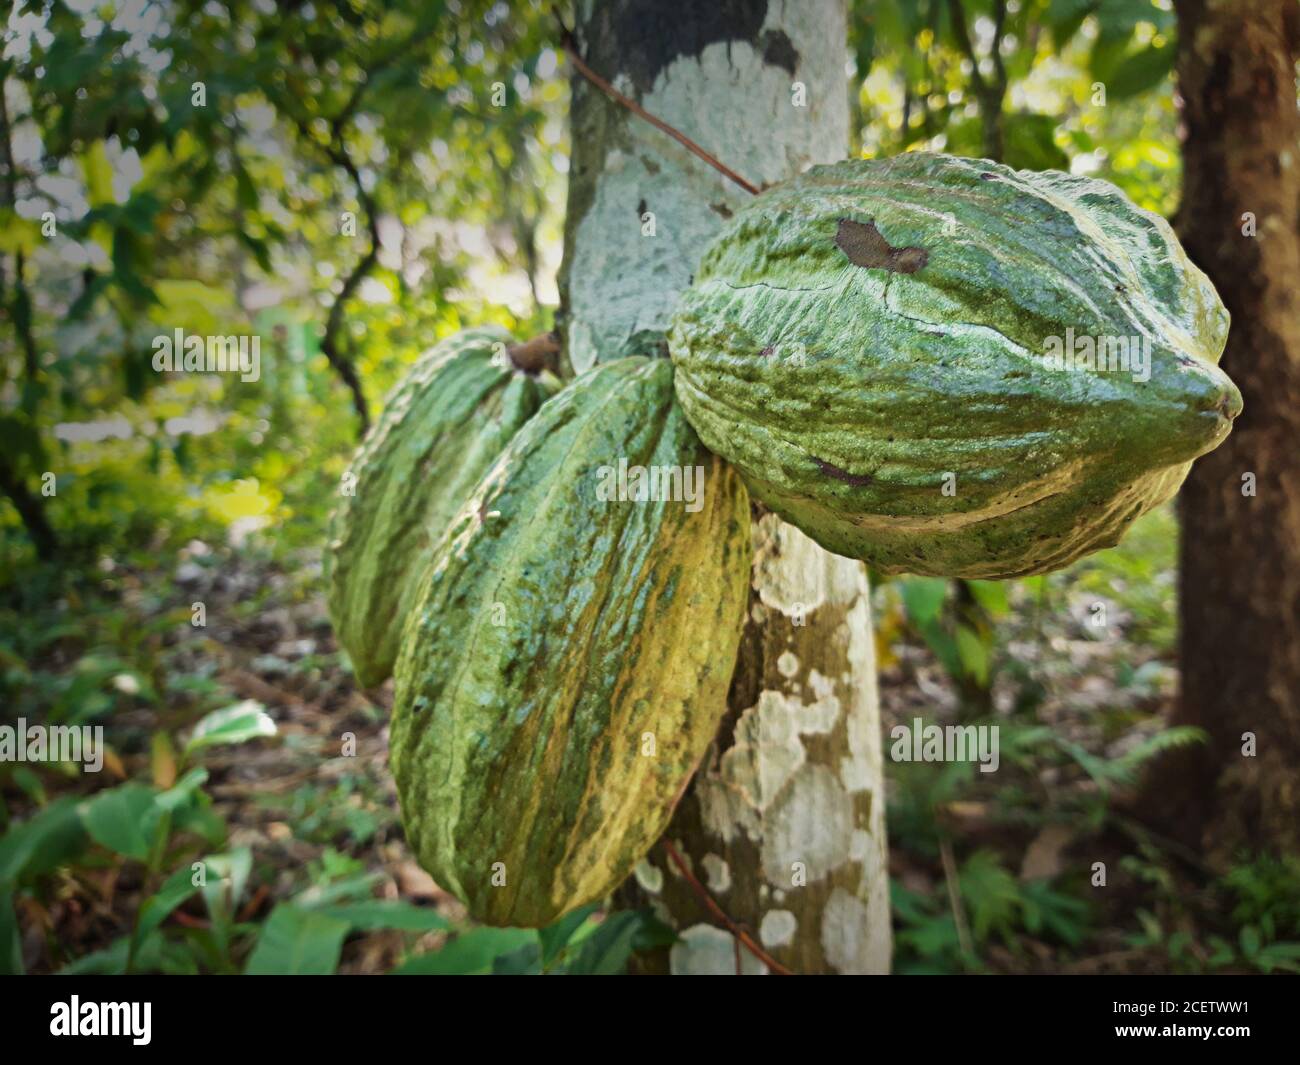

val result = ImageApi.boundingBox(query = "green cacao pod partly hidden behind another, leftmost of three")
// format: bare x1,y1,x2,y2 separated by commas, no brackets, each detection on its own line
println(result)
325,326,547,688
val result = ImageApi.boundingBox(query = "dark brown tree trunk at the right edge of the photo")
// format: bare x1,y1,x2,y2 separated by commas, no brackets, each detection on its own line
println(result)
1152,0,1300,862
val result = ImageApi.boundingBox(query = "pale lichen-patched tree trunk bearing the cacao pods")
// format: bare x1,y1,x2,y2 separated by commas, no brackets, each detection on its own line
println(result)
560,0,891,973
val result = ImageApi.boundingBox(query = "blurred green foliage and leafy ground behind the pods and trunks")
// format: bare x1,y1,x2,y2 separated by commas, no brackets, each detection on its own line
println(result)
0,0,1300,973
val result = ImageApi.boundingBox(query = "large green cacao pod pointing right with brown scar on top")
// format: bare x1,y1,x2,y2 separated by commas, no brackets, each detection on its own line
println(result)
670,152,1242,577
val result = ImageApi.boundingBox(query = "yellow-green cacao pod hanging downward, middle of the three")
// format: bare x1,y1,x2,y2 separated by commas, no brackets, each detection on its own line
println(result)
390,356,750,927
